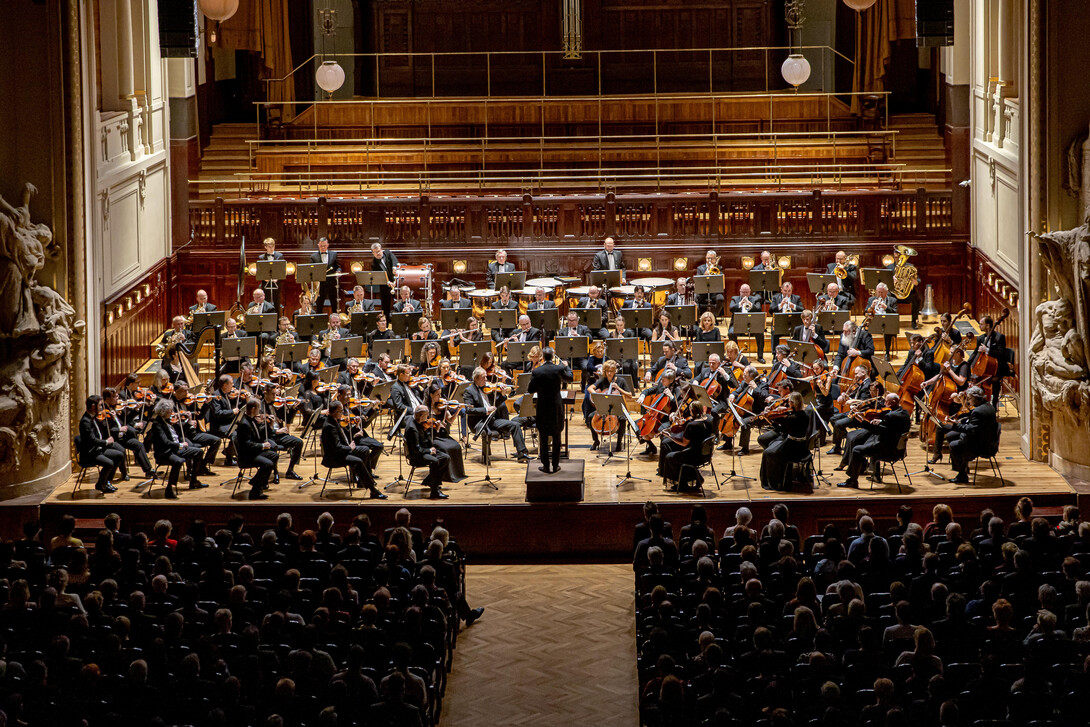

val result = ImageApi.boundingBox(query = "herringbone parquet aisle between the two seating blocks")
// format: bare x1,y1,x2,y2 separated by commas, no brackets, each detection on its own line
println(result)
441,565,639,727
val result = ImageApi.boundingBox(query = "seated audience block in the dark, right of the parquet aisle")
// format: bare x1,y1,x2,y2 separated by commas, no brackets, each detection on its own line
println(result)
633,498,1090,727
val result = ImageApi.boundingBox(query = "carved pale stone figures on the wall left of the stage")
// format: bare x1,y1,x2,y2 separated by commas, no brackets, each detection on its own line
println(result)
0,184,84,470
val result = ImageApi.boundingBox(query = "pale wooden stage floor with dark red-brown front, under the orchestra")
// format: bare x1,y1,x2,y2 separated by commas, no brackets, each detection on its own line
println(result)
40,420,1076,562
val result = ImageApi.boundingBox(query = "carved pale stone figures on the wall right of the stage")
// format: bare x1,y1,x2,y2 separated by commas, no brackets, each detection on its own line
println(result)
1029,217,1090,426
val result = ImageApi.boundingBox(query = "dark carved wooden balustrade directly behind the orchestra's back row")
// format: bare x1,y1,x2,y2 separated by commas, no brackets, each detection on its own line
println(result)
190,190,958,249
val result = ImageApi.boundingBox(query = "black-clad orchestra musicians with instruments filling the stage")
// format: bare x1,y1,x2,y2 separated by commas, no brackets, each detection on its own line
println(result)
91,238,1009,499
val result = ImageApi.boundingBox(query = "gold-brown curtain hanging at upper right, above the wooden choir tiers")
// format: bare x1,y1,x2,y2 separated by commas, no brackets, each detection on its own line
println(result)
851,0,916,113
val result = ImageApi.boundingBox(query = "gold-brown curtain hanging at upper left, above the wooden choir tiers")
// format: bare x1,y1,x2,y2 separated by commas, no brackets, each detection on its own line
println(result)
217,0,295,121
